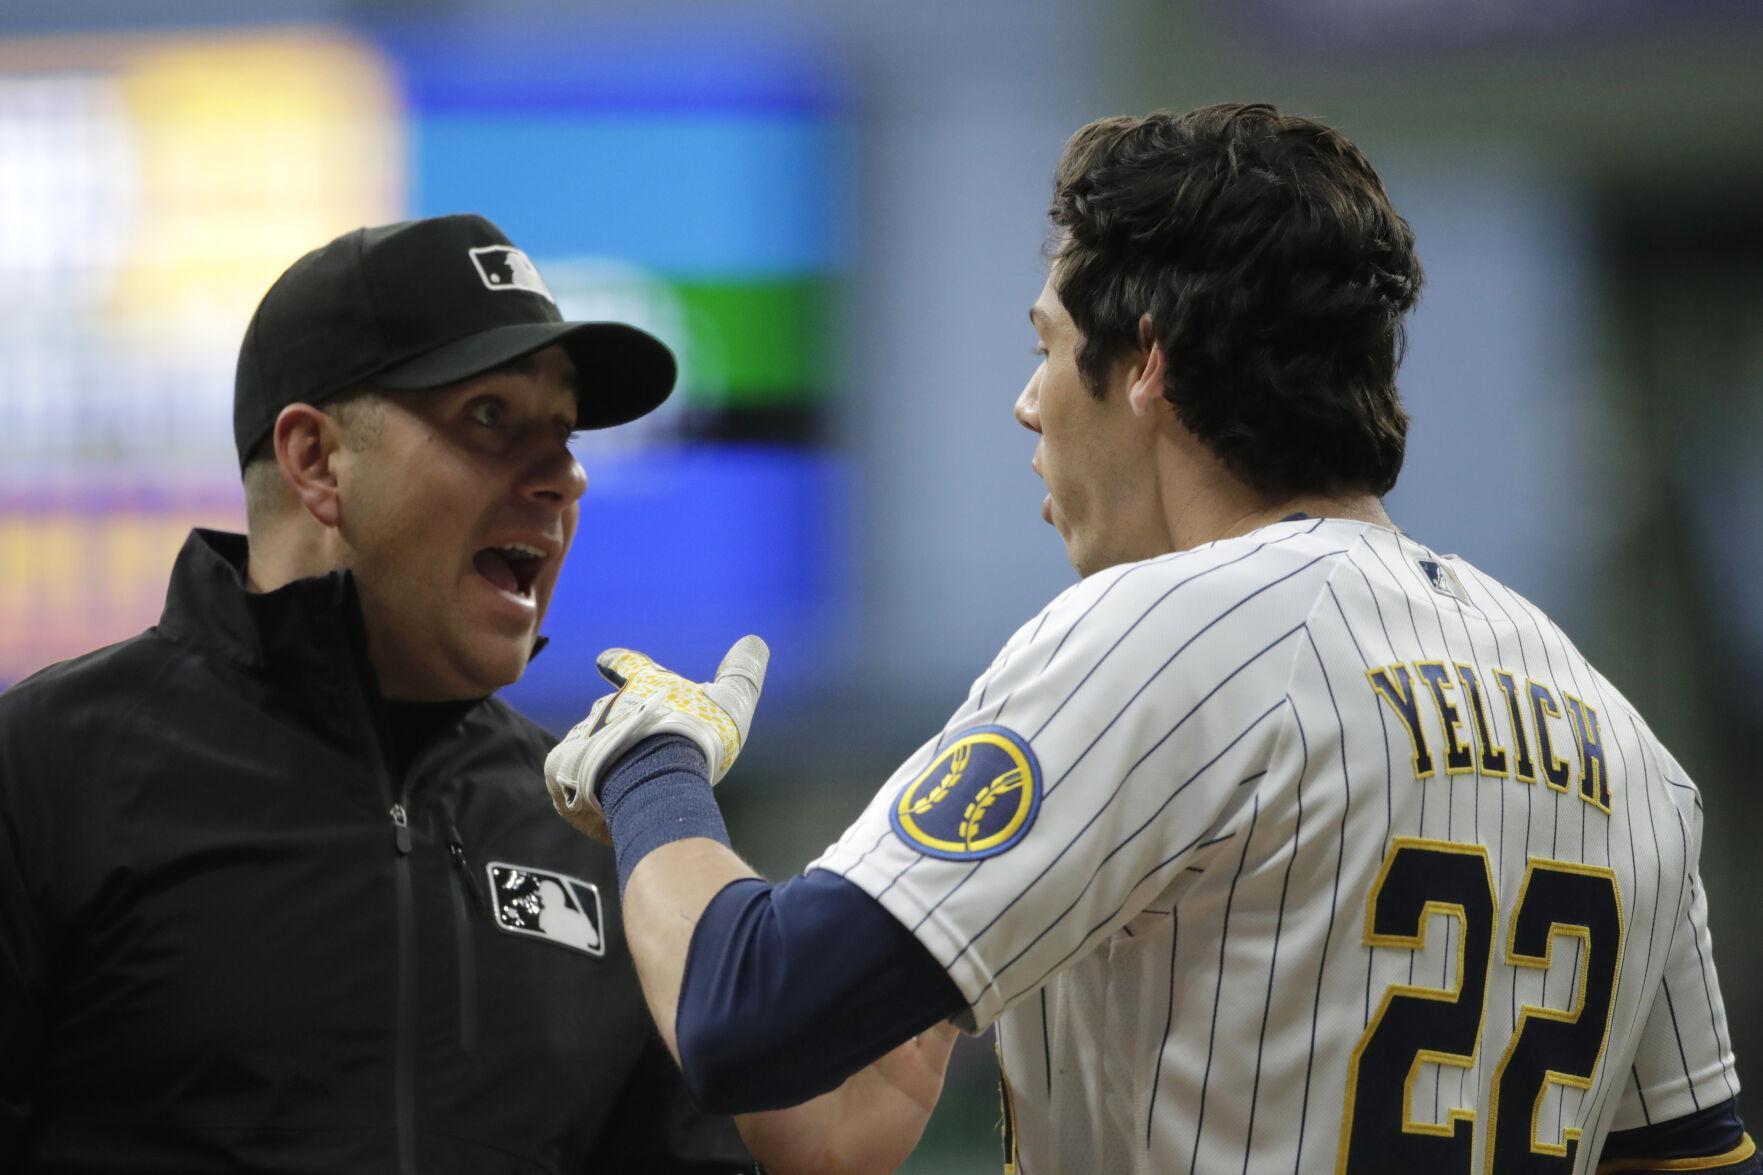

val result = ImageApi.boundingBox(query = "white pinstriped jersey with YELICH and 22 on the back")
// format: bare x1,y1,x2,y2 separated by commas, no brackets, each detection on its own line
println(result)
811,519,1738,1175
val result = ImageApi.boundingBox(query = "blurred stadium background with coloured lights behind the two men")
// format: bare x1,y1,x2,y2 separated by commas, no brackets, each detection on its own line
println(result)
0,0,1763,1173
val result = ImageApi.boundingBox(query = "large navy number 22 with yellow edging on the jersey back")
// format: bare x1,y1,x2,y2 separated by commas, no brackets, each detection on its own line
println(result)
1335,836,1627,1175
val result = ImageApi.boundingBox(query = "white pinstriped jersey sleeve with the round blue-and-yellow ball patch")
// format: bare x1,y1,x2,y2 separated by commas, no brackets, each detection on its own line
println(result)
809,547,1317,1032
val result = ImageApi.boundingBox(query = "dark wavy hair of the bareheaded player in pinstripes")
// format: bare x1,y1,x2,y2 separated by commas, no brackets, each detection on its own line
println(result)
1049,102,1421,494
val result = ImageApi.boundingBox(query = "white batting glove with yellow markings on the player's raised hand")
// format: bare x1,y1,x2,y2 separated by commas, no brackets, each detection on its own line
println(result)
545,635,770,843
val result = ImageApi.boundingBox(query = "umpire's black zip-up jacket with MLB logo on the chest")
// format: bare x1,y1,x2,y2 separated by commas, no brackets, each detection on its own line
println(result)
0,531,749,1175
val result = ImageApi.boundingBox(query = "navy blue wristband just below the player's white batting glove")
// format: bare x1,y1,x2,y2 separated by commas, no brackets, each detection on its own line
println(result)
599,734,728,894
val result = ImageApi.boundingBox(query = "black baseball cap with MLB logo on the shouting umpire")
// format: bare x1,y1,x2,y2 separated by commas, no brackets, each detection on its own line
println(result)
233,213,677,466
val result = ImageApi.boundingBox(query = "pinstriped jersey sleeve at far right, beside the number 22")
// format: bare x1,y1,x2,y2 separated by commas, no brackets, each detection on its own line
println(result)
1611,760,1738,1131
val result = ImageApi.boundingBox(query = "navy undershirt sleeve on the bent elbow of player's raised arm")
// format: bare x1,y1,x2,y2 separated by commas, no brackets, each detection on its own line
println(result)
675,870,968,1113
